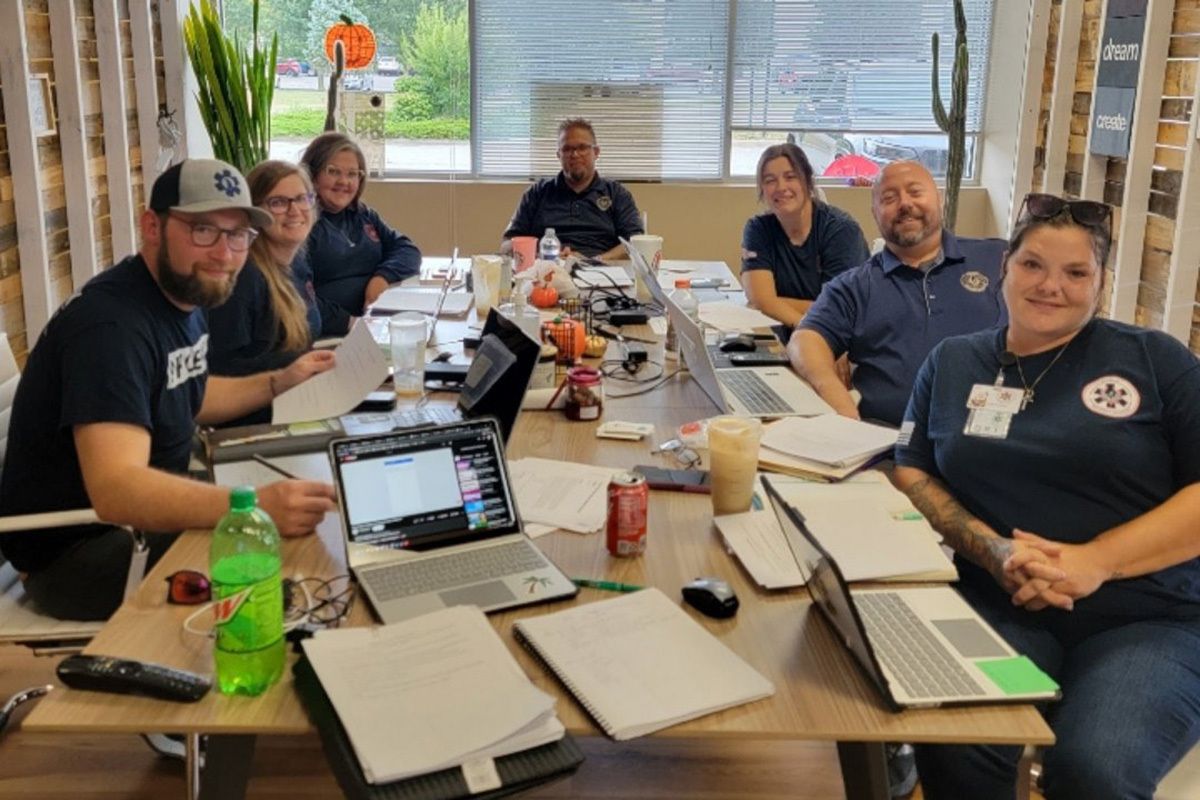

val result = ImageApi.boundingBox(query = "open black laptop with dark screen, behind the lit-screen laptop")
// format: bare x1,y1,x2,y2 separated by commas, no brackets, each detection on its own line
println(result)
341,308,541,441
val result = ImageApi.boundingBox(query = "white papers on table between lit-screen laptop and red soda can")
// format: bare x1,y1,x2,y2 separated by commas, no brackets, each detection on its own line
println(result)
509,458,618,534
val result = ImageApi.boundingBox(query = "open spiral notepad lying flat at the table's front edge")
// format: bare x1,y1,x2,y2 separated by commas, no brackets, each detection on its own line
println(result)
515,589,775,740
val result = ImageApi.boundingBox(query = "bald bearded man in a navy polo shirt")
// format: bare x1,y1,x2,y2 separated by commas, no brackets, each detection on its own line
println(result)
787,161,1006,426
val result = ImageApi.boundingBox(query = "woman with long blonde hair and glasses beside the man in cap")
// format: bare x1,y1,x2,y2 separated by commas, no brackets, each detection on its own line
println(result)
206,161,320,426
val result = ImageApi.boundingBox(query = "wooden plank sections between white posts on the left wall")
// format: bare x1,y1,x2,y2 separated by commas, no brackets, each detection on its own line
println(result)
0,0,163,363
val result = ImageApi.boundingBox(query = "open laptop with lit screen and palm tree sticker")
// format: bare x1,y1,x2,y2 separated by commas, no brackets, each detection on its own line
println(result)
329,417,577,622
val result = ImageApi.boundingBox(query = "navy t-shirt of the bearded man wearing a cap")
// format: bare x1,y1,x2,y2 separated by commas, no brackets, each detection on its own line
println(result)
0,255,209,572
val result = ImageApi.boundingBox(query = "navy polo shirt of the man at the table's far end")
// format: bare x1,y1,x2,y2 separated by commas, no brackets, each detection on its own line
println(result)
504,173,643,255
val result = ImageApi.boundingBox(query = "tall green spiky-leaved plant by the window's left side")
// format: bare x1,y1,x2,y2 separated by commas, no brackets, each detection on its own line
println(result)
184,0,278,174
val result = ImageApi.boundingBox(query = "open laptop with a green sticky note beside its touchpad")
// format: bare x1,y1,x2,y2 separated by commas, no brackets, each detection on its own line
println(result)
762,476,1060,711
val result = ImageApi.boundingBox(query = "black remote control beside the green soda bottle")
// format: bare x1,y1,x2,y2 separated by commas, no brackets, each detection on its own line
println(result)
58,655,212,703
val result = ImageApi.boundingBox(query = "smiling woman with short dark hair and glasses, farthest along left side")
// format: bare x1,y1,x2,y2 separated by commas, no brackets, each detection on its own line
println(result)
300,132,421,336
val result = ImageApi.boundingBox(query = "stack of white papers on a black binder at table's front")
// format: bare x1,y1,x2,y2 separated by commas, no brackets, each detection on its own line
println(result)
295,606,582,800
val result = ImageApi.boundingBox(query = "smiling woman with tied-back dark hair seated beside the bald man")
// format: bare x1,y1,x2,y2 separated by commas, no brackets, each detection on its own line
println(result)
742,143,870,326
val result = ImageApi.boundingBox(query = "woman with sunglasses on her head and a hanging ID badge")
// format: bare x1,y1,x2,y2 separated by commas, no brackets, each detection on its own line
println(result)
895,194,1200,800
